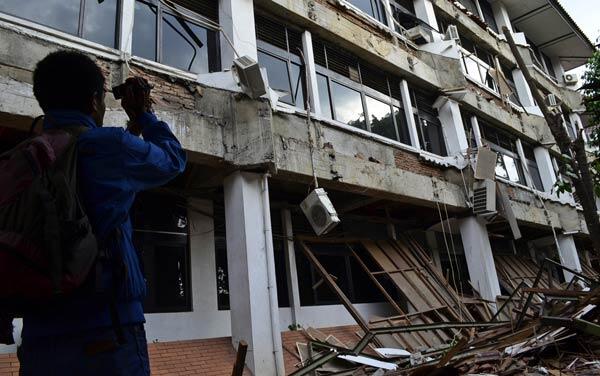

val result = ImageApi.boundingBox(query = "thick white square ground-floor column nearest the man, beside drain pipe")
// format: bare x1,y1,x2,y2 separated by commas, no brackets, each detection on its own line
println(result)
224,171,283,375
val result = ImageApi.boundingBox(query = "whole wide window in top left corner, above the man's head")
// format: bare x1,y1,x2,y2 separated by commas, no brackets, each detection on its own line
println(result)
0,0,118,47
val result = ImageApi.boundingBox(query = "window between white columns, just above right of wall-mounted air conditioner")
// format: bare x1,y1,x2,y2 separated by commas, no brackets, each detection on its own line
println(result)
478,119,526,185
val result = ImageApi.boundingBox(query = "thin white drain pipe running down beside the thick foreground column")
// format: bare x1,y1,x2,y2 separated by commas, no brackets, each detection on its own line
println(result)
262,173,285,376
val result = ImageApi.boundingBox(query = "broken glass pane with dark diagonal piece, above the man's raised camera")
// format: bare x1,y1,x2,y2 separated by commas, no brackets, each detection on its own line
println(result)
161,14,210,73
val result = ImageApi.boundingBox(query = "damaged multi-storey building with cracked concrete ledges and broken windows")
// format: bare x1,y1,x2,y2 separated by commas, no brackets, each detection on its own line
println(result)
0,0,596,375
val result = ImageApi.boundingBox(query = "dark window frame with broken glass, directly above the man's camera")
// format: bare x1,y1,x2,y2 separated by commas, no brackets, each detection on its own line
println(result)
134,0,221,74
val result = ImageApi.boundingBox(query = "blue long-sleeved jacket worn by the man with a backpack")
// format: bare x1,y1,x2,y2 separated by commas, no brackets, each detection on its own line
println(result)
22,111,186,337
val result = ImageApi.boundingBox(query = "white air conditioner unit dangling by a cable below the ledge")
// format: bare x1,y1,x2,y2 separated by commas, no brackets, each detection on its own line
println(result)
300,188,340,235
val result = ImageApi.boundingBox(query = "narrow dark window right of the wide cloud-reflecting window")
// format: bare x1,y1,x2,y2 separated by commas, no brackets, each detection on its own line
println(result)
411,89,447,156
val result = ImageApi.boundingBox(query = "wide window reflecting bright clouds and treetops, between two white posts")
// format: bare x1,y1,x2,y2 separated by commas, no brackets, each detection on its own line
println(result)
313,38,410,145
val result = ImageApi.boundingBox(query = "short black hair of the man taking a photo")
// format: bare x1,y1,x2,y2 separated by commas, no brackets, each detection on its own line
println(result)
33,50,104,112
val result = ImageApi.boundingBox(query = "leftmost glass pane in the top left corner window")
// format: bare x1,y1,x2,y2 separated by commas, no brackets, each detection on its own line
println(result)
0,0,80,35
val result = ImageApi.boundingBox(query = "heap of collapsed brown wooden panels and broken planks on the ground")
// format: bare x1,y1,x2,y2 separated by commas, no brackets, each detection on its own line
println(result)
293,236,600,376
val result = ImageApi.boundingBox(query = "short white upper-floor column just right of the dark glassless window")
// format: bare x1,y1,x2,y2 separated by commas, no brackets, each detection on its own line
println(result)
433,97,469,156
